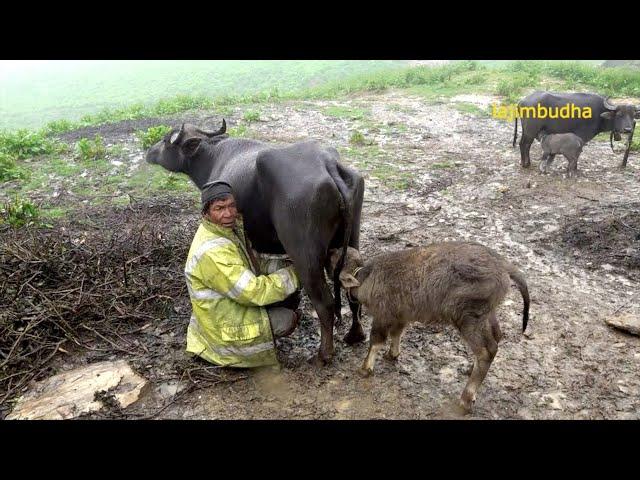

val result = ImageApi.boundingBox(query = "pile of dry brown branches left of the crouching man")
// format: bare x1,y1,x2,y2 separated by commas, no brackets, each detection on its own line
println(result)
0,197,198,410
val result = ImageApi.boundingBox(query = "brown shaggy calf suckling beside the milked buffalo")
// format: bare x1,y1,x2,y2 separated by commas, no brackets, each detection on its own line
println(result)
328,242,529,413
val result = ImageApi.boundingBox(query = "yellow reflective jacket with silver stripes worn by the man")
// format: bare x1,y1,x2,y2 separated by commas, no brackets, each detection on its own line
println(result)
184,217,300,367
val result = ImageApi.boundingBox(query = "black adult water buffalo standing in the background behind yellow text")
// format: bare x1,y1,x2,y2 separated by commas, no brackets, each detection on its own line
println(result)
513,92,640,168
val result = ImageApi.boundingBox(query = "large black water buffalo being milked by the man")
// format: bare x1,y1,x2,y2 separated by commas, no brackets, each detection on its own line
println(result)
146,120,365,364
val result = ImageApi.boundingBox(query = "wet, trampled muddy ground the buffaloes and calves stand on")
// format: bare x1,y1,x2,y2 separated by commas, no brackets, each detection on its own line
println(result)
10,88,640,419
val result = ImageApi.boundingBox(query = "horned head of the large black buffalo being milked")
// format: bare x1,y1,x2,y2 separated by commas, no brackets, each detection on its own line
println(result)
145,119,227,173
